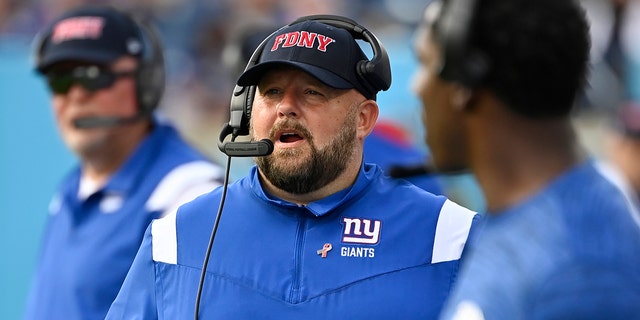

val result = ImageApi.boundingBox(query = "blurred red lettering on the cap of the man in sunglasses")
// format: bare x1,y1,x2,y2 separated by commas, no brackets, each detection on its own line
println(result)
51,17,104,43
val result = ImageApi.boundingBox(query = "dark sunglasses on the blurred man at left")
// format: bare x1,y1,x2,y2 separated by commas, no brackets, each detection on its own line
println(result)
46,66,136,94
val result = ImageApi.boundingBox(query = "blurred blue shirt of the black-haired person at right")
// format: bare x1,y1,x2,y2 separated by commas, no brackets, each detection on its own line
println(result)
442,161,640,320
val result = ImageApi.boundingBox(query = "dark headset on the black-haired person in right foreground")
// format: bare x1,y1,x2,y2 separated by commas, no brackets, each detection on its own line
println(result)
430,0,490,88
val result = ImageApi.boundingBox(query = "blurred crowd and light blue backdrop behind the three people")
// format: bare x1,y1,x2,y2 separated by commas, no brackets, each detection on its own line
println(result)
0,0,640,319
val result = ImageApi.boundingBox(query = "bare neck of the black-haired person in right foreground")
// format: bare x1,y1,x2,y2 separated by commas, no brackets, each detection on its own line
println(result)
471,102,585,213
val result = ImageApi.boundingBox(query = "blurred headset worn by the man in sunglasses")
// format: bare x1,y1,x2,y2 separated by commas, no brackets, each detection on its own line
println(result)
34,7,166,128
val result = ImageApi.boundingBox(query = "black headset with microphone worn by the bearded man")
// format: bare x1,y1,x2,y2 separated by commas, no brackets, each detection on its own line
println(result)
218,15,391,157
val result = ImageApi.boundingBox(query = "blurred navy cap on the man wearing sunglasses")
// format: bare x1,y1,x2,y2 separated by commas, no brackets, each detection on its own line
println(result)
36,5,144,73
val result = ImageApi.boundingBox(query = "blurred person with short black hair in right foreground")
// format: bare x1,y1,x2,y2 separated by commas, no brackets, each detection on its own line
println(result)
414,0,640,320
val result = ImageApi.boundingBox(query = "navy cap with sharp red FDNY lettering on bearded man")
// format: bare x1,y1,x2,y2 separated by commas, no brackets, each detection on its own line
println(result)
238,20,377,99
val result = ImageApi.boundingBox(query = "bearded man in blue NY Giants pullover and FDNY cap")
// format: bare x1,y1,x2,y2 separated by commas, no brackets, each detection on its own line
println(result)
107,16,478,319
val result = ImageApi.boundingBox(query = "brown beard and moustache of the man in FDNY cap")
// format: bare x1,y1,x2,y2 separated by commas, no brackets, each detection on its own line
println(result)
256,107,357,194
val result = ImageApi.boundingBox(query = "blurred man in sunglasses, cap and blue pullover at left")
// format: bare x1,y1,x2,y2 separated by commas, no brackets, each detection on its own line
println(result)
25,6,222,320
